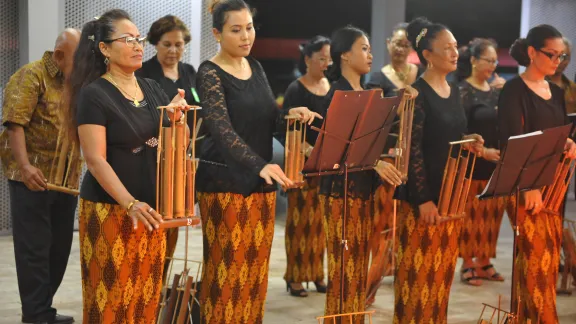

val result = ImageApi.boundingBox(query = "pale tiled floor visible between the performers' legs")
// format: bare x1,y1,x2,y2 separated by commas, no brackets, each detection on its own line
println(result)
0,196,576,324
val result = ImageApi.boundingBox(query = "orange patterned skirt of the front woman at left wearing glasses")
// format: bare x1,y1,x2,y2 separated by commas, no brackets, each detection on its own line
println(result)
79,199,166,324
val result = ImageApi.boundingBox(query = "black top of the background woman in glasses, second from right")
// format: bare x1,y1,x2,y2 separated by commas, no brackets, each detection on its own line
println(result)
460,81,500,180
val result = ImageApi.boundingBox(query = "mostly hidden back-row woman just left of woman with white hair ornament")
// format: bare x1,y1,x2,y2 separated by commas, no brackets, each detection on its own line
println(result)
366,23,419,305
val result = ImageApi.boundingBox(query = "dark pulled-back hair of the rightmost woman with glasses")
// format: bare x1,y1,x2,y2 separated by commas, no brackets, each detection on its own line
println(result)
510,25,562,66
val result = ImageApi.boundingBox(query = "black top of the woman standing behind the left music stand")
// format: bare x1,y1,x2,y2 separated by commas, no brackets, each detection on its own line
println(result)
320,77,380,200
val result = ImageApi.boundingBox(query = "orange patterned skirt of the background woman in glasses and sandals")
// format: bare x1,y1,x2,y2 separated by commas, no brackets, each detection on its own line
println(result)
460,180,507,259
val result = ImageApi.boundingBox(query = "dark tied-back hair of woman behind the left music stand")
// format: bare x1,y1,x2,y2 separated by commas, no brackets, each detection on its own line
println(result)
326,26,368,82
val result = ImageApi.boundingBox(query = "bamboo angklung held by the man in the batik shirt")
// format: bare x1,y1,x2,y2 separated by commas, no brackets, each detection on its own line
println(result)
47,128,82,196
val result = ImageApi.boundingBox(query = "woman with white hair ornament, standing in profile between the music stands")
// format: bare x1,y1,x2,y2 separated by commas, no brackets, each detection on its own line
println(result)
394,18,483,323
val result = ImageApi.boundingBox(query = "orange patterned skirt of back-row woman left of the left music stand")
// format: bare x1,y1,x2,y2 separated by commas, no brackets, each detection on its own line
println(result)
284,178,326,283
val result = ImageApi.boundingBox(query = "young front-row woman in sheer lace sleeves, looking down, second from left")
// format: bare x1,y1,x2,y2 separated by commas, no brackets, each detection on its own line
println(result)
196,0,320,323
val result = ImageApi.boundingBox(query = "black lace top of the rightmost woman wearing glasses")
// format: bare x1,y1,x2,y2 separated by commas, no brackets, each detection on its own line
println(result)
498,76,570,149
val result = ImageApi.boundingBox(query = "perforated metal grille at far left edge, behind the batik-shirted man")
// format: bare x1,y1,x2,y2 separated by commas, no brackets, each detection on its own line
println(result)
0,0,20,234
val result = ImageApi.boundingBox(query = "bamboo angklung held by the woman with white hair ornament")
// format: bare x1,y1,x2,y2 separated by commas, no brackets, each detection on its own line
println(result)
438,139,476,221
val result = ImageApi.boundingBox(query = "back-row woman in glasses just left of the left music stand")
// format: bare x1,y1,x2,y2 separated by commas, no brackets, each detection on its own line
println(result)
283,36,330,297
